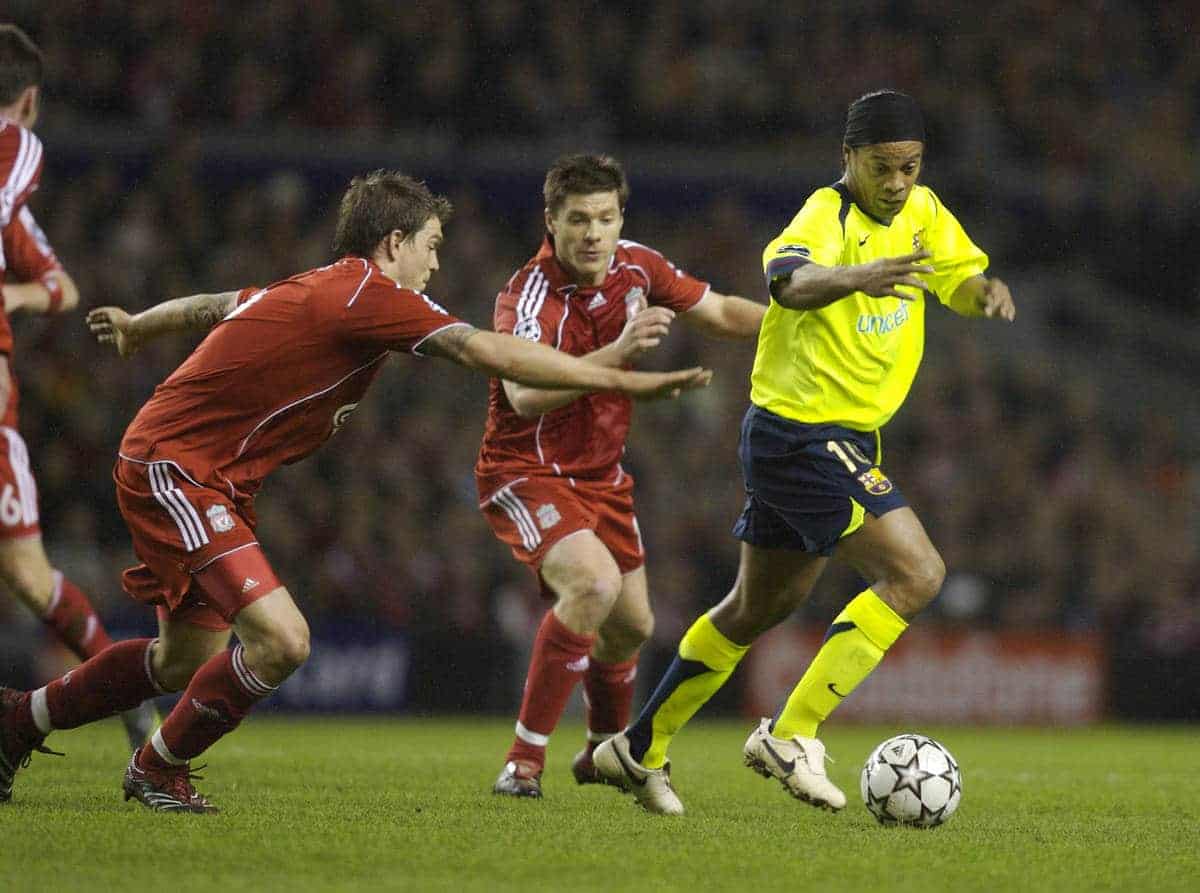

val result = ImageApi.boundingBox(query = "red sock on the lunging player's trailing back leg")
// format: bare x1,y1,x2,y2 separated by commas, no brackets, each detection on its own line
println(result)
43,639,163,729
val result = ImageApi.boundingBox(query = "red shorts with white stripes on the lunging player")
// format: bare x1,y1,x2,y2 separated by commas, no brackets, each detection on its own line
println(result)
113,459,280,630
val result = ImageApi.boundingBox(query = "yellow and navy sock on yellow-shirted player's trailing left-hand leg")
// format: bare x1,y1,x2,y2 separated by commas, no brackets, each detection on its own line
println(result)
626,613,750,769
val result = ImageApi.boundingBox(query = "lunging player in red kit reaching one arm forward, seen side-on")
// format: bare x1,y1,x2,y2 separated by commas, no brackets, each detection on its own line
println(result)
0,170,710,813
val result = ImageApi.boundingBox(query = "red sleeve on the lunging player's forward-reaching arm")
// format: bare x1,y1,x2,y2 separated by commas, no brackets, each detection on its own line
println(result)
344,280,469,354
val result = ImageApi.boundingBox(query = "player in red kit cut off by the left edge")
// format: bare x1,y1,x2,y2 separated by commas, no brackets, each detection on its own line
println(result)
0,25,156,745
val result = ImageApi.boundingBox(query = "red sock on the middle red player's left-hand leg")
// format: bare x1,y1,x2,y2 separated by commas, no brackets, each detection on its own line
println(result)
508,611,596,769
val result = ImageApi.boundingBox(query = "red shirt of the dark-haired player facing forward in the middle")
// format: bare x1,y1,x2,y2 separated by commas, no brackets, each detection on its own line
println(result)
475,236,708,487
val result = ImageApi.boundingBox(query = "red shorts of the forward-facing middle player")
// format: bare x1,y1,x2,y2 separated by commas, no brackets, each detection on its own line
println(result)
480,472,646,588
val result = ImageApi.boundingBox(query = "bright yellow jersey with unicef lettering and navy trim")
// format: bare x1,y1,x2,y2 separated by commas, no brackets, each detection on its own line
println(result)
750,182,988,431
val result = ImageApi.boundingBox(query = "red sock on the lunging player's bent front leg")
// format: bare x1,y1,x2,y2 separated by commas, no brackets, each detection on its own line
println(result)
138,645,275,767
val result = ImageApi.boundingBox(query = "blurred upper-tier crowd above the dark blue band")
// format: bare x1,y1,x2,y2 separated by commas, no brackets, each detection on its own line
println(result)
10,0,1200,318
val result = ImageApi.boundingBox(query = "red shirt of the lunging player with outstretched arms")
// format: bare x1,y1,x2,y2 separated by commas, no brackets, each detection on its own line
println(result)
121,257,467,499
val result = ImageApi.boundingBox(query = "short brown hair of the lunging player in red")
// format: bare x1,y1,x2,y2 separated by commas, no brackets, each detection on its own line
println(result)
334,170,454,258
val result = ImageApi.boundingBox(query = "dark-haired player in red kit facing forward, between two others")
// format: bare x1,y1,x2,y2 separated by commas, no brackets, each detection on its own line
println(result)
475,155,766,797
